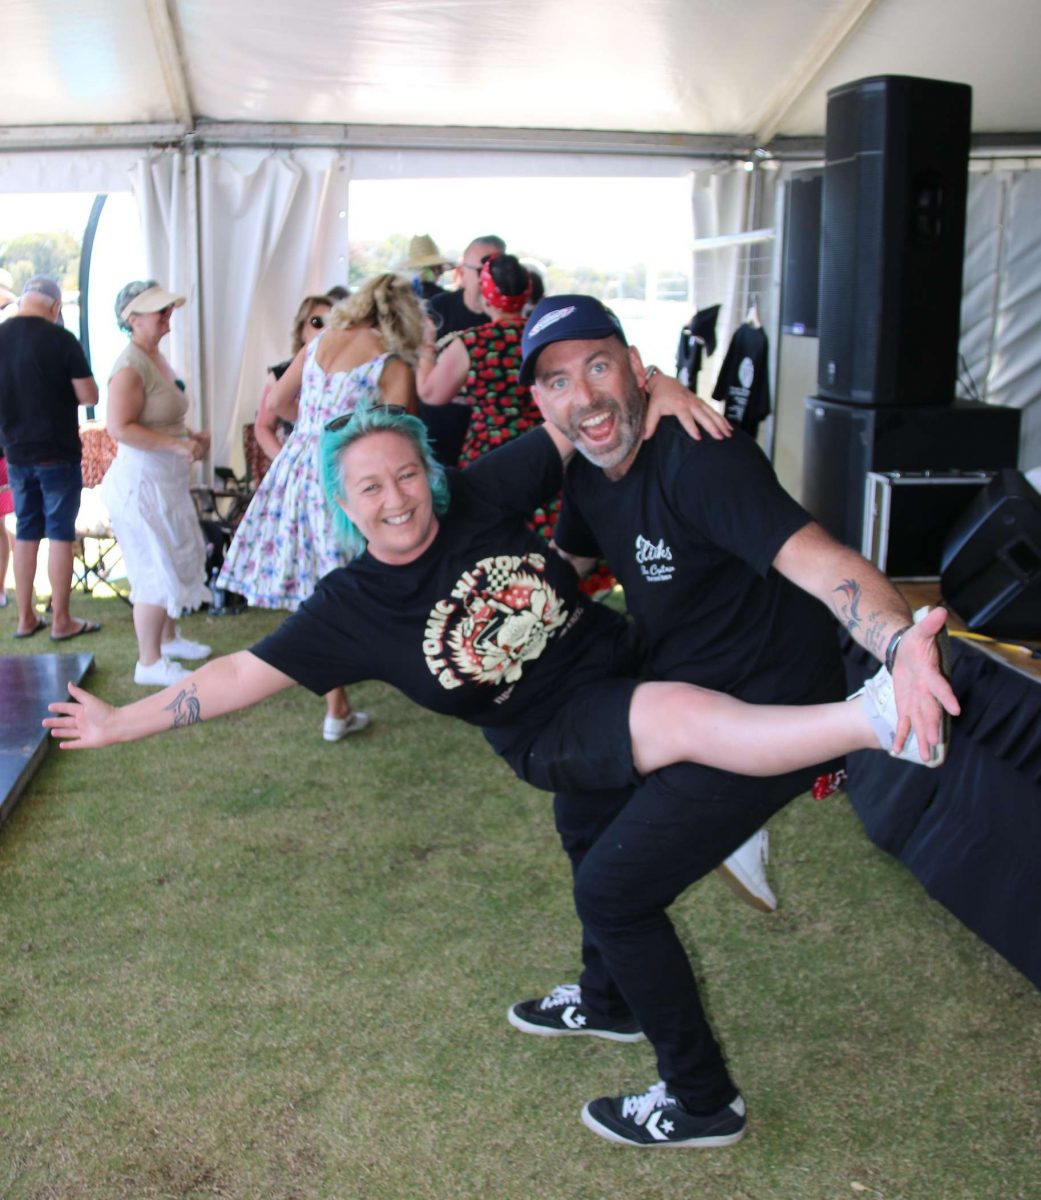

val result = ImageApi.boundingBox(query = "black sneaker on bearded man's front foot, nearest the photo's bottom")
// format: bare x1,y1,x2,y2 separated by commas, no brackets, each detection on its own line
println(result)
582,1080,745,1150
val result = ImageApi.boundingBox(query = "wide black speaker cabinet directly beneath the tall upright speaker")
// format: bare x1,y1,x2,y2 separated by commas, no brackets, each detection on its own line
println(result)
802,396,1021,550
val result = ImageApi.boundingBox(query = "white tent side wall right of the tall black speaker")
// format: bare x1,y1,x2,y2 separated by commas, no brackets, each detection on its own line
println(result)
961,169,1041,470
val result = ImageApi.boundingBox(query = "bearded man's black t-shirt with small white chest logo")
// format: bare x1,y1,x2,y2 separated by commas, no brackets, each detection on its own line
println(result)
554,419,842,703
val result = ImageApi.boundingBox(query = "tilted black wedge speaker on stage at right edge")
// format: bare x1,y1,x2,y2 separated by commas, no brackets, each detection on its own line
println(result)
940,470,1041,640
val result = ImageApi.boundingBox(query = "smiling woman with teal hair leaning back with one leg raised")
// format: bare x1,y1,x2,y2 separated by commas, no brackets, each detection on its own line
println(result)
44,404,917,791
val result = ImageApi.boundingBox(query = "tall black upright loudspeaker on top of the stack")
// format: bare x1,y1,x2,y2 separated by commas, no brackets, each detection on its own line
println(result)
817,76,973,406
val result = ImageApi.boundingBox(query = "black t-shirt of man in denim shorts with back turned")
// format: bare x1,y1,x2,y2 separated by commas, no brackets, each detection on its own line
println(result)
0,317,90,467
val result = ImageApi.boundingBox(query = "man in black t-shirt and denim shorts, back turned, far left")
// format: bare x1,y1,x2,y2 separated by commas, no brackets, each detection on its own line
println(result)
0,275,101,642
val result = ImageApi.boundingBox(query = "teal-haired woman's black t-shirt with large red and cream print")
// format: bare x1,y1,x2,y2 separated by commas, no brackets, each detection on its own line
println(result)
252,430,627,728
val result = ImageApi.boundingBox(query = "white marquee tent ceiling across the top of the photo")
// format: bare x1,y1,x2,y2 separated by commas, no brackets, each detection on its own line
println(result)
0,0,1041,150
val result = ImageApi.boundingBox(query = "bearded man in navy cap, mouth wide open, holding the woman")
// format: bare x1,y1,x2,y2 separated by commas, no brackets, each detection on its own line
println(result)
509,295,957,1147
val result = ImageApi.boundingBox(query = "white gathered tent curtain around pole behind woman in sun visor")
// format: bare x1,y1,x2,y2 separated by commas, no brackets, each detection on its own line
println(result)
133,150,350,470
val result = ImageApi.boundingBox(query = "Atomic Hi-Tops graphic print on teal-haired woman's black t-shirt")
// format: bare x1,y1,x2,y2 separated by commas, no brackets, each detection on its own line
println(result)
423,553,568,688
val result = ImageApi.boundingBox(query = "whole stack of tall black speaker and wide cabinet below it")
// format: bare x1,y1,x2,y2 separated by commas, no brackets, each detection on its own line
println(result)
796,76,1019,633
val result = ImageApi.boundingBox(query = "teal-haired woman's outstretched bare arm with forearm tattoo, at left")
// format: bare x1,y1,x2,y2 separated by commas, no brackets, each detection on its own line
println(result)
43,650,294,750
